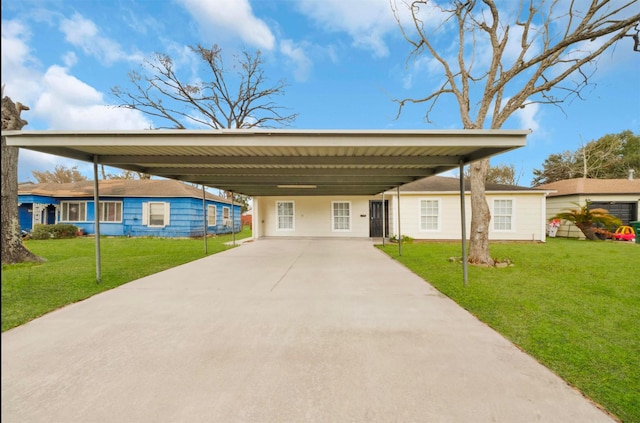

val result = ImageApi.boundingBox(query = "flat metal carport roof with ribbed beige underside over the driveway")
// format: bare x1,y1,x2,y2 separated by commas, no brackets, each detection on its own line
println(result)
2,129,530,196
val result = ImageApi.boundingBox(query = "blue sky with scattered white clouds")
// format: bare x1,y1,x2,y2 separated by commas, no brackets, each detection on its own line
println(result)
2,0,640,186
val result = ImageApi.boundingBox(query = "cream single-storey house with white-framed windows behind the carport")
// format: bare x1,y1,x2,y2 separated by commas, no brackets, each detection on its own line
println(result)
253,176,548,241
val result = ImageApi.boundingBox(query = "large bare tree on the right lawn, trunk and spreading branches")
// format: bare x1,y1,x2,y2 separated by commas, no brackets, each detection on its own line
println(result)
391,0,640,264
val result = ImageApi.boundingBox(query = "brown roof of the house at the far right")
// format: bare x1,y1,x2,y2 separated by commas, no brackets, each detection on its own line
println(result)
537,178,640,197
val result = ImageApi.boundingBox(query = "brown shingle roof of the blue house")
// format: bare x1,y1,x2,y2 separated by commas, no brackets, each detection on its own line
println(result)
18,179,230,203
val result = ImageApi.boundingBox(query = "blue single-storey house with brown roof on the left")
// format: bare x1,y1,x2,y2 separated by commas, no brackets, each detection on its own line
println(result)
18,179,241,237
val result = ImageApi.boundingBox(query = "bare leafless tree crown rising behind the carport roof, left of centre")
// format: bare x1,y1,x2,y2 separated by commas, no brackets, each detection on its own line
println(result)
111,45,297,129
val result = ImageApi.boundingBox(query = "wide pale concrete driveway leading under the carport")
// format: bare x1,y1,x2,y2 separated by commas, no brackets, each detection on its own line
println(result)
2,239,614,423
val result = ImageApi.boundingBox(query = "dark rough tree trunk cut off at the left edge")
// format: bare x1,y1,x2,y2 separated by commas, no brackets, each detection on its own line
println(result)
0,86,42,264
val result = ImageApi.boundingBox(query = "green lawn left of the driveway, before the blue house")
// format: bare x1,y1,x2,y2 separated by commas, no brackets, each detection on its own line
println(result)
2,227,251,332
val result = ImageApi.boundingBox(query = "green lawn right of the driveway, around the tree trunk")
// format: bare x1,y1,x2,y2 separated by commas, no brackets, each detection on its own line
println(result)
380,238,640,423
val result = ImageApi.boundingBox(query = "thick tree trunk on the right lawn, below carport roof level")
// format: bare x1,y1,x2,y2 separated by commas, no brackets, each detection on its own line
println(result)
468,160,495,266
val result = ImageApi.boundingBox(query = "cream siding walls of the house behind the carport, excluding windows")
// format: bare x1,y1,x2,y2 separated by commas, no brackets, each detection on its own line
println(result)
253,193,546,241
